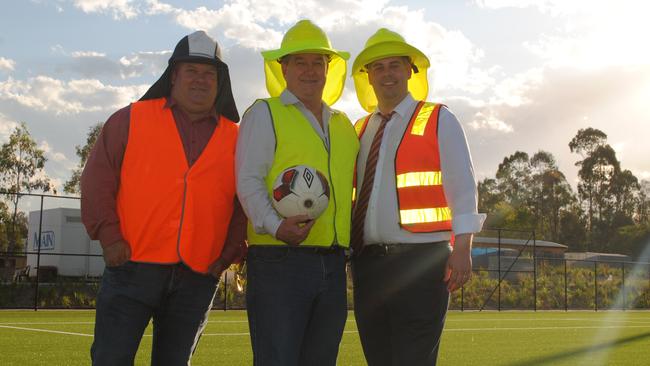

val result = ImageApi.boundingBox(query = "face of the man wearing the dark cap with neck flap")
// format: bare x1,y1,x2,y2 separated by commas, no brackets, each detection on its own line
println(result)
171,62,217,120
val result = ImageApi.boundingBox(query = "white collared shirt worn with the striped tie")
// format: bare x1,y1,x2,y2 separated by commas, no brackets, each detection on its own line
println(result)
357,94,485,244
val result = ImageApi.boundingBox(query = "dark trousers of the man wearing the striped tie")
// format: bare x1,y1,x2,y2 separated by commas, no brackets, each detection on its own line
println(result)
352,242,450,366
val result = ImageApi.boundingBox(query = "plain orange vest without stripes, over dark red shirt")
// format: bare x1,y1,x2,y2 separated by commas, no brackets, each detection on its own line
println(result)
117,98,238,273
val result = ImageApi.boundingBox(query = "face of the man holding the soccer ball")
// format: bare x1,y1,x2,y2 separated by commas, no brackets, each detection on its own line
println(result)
282,53,327,104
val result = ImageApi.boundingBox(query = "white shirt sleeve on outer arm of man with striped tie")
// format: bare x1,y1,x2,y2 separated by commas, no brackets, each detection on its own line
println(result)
438,107,486,235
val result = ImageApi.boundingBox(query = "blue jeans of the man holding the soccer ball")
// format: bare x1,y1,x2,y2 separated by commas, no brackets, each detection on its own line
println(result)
246,246,347,366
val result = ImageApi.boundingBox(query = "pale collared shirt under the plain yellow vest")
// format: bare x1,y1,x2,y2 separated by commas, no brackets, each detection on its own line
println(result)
235,89,332,237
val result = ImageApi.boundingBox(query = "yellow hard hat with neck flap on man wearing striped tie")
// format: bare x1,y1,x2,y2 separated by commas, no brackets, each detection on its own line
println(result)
352,28,430,112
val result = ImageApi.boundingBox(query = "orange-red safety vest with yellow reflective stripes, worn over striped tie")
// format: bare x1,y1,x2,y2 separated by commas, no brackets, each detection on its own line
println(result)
354,101,451,233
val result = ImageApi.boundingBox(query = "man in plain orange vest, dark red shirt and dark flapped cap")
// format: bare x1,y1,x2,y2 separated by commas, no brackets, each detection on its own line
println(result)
81,31,246,365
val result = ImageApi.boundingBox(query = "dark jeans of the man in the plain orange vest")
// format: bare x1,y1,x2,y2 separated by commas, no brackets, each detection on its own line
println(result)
90,262,218,366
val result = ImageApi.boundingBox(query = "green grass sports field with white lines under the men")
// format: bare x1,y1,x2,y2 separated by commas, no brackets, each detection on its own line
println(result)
0,310,650,366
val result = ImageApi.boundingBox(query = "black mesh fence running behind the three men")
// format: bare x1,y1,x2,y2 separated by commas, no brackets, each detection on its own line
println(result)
0,192,650,310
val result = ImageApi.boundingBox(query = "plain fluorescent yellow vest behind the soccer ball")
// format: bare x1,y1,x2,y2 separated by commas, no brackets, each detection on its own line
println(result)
248,98,359,247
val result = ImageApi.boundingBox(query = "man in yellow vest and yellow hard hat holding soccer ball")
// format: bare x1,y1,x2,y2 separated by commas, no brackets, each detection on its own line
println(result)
236,20,359,366
